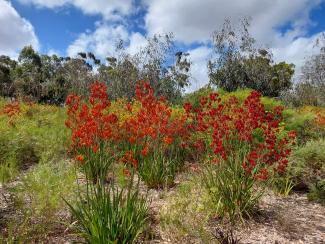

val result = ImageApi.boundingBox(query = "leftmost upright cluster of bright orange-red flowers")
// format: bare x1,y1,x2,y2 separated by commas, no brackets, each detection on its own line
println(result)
65,81,118,161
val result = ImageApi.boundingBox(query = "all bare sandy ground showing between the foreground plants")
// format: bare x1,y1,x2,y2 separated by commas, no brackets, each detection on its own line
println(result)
0,178,325,244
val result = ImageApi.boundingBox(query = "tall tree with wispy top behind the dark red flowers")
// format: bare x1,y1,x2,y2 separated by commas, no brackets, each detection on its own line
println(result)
208,18,294,96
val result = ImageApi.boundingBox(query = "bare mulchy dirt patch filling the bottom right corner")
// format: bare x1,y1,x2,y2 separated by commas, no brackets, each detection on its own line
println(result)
228,194,325,244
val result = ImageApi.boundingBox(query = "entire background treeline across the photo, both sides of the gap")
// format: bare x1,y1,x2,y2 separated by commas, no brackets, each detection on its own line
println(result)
0,19,325,106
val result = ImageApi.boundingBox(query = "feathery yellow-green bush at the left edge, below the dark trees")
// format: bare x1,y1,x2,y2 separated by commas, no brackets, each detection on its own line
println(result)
0,100,69,182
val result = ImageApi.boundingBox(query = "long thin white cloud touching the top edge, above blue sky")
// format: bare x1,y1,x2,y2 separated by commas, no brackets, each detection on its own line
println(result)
19,0,133,19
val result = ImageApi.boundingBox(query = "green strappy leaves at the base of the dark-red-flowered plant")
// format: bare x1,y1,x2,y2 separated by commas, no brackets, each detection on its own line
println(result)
202,158,264,223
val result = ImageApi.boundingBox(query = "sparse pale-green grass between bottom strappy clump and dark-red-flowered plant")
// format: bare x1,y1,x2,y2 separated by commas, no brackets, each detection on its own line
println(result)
159,176,216,243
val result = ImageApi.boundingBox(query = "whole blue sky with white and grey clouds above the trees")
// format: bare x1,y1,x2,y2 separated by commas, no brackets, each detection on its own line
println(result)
0,0,325,89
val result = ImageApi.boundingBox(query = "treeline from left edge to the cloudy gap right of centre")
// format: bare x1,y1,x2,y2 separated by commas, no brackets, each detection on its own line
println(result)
0,34,190,104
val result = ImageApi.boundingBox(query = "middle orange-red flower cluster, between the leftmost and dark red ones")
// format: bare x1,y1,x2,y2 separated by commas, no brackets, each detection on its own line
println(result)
123,81,186,160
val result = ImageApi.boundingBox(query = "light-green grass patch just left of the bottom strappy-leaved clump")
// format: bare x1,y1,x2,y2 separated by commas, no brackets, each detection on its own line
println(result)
15,161,77,219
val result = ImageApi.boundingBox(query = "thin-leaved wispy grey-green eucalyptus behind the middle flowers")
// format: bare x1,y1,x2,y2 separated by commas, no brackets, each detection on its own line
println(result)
97,34,190,102
